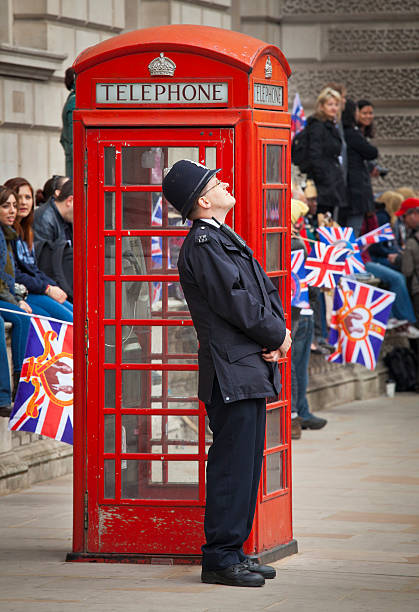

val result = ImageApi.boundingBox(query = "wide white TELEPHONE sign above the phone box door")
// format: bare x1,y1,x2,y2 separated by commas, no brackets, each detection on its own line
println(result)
96,82,228,104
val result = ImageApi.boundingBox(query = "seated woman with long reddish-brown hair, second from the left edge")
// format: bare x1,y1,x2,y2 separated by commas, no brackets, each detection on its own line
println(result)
5,177,73,322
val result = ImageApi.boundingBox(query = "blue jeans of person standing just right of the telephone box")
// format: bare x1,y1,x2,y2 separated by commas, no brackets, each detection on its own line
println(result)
291,315,314,419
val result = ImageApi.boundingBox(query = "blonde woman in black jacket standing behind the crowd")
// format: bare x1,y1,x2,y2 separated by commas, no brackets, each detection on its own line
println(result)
307,87,346,216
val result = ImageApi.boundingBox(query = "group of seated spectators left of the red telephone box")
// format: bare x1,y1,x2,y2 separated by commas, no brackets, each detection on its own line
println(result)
0,176,73,417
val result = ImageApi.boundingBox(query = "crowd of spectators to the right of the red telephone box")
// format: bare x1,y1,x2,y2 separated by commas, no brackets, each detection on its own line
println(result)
292,83,419,439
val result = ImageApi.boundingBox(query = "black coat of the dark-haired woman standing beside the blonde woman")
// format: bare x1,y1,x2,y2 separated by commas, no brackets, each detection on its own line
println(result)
345,127,378,215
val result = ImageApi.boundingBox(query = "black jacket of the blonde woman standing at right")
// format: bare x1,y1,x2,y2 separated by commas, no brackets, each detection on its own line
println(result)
307,116,346,210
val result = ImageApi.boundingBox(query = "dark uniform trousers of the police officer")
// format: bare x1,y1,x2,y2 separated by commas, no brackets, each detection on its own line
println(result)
202,379,266,570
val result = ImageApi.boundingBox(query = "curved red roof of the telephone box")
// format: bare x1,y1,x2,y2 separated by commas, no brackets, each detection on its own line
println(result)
73,25,291,77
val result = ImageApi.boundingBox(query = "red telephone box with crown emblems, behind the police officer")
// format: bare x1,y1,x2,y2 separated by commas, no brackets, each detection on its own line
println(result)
68,25,297,563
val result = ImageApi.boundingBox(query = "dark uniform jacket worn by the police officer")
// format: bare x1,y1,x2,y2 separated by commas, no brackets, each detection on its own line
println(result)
178,220,286,403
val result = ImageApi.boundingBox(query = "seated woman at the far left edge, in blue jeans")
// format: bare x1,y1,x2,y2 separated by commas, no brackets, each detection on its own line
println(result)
0,186,32,404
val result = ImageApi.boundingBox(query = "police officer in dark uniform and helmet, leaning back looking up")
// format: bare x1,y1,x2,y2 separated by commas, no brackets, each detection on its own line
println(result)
163,159,291,586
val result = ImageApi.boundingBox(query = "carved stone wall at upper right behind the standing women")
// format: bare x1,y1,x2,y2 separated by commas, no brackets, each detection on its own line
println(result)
240,0,419,191
